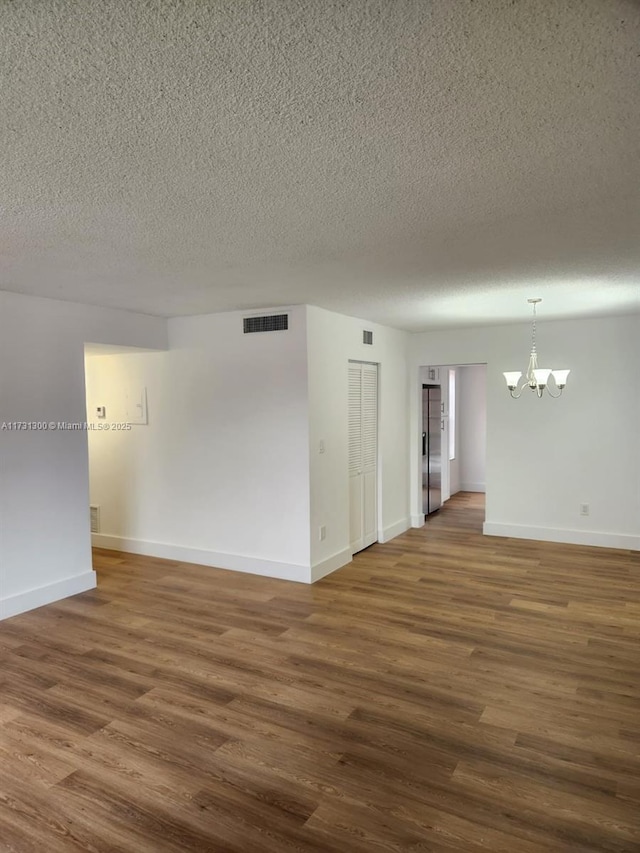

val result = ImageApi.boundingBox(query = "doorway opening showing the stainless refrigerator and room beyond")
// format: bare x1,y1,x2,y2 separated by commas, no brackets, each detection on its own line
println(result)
420,364,487,527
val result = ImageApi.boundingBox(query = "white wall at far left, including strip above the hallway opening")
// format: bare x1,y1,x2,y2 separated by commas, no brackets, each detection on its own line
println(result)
0,292,167,618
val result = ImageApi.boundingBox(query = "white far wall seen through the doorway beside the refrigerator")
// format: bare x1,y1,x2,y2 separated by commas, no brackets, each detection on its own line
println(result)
456,364,487,492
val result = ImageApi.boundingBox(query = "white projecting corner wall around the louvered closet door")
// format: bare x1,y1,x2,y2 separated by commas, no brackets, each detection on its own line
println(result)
87,306,409,582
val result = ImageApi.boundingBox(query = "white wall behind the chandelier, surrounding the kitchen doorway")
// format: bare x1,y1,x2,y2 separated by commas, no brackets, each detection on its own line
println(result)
410,314,640,548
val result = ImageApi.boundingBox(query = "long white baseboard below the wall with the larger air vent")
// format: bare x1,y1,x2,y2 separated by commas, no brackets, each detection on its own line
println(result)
91,533,311,583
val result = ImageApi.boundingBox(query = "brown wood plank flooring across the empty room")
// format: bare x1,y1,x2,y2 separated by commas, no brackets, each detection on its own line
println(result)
0,494,640,853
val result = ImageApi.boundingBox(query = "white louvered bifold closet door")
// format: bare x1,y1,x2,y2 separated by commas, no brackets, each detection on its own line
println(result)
349,361,378,554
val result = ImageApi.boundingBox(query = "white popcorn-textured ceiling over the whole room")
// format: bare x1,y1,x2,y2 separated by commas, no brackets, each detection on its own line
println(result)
0,0,640,329
